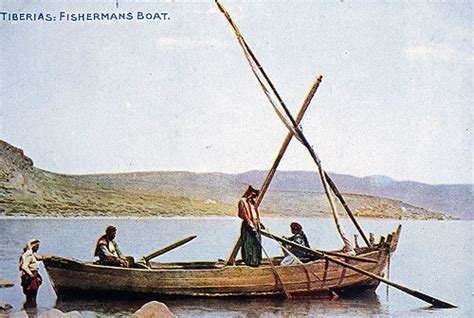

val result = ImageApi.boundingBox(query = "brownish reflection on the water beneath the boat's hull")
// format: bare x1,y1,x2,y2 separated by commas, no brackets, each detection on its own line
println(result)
55,291,384,317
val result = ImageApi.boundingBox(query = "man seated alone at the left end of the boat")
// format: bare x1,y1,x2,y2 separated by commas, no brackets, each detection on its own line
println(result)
94,225,134,267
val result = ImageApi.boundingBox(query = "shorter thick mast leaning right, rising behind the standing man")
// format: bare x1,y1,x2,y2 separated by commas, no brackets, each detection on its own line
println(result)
226,75,323,265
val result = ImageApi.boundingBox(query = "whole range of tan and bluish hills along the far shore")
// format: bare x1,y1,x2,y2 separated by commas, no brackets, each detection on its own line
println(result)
0,141,466,219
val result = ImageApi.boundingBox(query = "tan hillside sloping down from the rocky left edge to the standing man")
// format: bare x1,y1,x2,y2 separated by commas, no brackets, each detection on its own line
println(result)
0,140,234,216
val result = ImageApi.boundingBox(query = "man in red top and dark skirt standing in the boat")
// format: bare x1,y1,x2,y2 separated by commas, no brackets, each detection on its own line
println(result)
239,185,262,267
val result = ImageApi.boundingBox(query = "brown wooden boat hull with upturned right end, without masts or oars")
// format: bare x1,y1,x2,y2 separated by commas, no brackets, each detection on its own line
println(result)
43,228,400,298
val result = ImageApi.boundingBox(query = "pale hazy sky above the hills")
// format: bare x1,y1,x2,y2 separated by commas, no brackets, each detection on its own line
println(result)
0,0,474,183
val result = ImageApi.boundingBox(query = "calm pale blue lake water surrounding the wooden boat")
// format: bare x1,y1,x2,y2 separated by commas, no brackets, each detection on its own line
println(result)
0,218,474,317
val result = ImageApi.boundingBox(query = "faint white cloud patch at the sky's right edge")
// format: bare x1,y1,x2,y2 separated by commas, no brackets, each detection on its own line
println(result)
404,46,473,63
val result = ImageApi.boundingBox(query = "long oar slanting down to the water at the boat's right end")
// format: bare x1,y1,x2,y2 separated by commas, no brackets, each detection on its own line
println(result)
261,230,457,308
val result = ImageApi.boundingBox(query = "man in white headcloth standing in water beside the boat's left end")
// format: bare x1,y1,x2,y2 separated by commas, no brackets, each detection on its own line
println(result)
18,239,43,307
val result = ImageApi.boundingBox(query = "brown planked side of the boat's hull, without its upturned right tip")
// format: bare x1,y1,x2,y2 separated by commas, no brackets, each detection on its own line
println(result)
45,247,387,296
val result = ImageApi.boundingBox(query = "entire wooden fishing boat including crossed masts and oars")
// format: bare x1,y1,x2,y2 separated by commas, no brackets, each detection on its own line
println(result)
43,0,455,308
